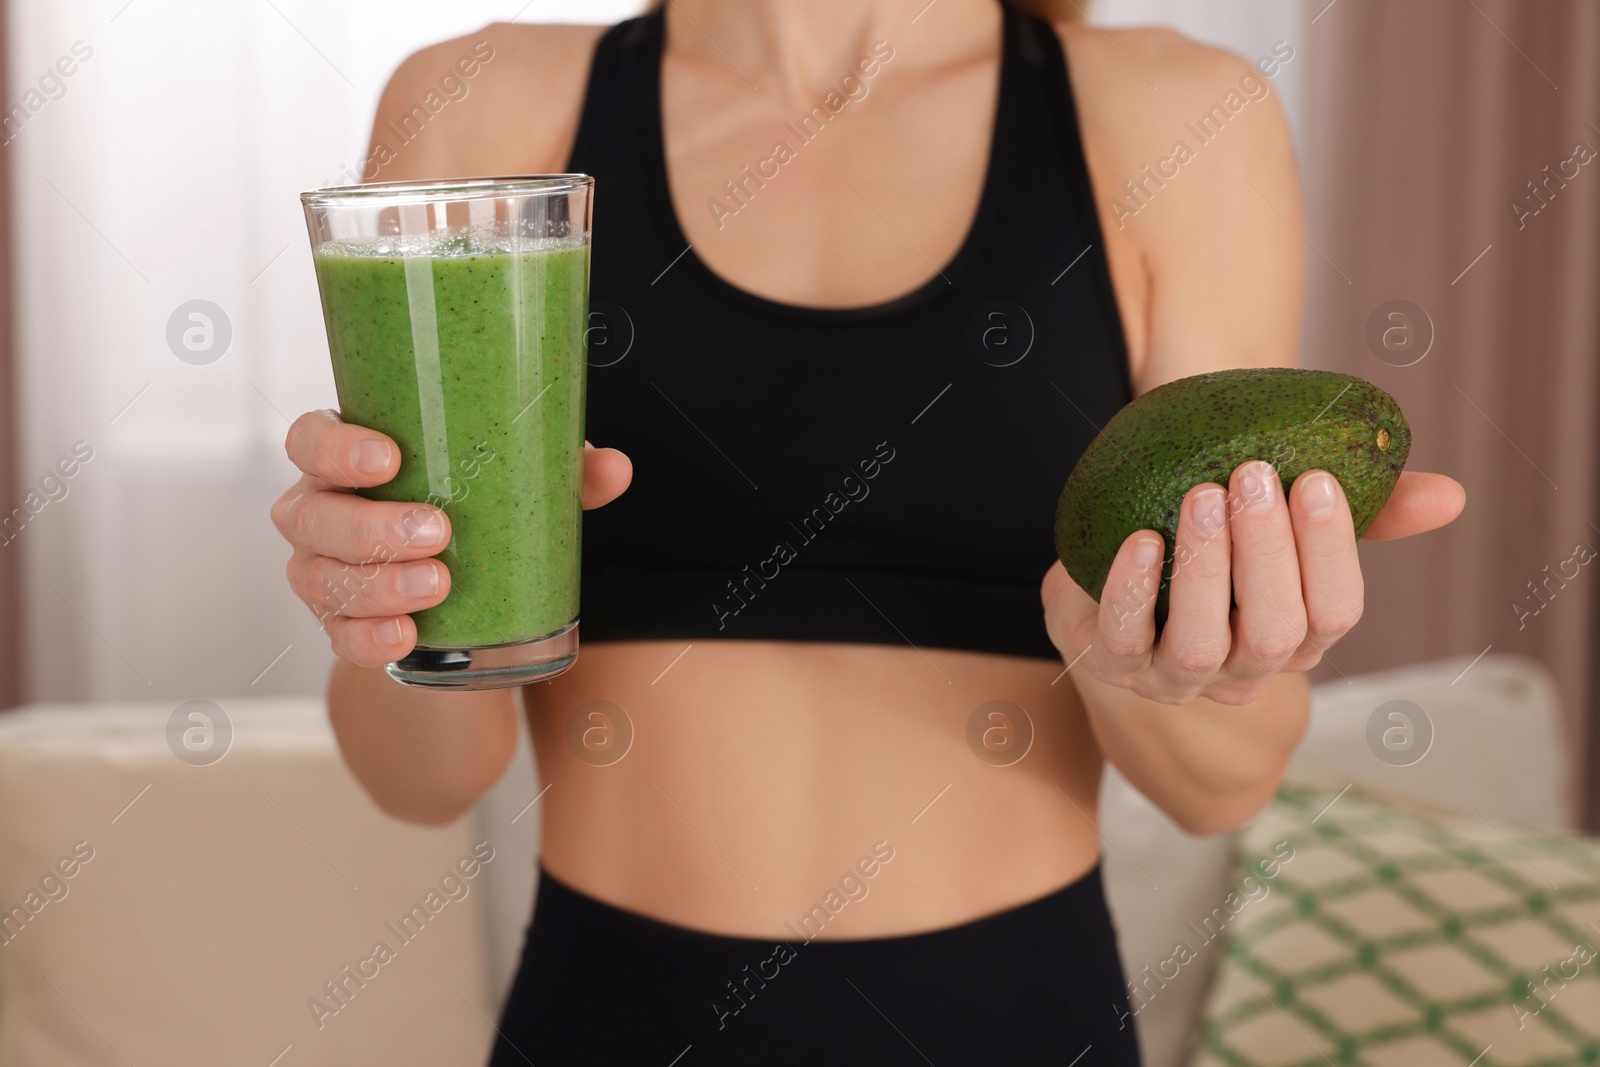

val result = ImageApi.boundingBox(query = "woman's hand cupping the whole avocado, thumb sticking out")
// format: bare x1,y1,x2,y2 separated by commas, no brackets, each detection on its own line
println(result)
1042,461,1466,704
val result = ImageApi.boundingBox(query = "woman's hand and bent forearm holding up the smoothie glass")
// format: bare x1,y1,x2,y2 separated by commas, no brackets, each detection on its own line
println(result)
272,411,632,824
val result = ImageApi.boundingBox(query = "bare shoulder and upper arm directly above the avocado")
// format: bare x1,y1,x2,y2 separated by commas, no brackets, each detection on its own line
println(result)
1056,24,1306,389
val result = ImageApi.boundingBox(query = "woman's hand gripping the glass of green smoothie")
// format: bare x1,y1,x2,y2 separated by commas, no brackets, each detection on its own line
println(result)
272,410,634,667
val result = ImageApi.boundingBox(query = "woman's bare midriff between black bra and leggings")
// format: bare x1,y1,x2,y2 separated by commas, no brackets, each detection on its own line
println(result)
523,640,1101,939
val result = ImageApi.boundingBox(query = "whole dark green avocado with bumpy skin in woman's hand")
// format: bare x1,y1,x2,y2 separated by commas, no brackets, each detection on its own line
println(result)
1056,368,1411,627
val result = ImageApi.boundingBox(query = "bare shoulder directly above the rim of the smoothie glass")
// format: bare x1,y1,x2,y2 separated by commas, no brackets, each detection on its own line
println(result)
365,22,608,181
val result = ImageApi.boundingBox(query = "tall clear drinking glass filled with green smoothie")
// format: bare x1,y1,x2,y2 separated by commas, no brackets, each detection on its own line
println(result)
301,174,594,689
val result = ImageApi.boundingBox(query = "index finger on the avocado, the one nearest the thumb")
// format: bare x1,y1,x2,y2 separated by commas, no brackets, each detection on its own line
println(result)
1288,470,1365,670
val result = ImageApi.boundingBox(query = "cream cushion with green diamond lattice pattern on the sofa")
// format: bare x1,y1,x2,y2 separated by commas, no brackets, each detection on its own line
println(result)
1190,777,1600,1067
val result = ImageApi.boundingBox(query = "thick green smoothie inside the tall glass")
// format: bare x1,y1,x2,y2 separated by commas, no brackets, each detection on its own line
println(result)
314,237,589,649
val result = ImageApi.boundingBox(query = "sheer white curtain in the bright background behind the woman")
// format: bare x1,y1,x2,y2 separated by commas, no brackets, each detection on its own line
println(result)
15,0,1304,702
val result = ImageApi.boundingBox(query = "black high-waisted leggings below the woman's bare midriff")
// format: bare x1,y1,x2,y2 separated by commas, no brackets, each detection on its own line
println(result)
490,867,1139,1067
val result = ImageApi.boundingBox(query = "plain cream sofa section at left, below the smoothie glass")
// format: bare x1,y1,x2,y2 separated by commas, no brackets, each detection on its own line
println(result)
0,699,499,1067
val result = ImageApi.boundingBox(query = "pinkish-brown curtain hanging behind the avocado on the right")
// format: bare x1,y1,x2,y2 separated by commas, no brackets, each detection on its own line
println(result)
1301,0,1600,827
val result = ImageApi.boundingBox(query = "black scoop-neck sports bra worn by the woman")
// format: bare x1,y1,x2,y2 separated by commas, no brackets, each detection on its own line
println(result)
570,6,1131,659
